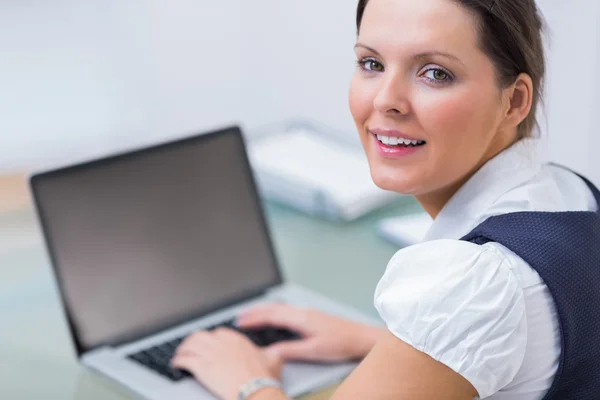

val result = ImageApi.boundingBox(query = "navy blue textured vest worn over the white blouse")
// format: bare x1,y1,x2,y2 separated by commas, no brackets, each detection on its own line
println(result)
461,173,600,400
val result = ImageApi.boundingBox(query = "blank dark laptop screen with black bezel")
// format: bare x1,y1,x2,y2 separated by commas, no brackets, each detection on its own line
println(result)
31,128,281,353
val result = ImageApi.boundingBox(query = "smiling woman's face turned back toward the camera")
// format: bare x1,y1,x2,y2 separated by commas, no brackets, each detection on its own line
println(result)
350,0,509,205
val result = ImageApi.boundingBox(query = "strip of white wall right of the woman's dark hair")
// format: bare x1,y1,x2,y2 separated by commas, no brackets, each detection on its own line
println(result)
538,0,600,184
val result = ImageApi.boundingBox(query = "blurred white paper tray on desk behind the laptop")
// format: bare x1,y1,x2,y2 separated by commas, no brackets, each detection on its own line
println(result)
248,122,400,221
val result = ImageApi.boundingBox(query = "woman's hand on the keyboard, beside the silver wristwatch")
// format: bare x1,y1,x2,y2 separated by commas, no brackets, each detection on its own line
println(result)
171,328,283,400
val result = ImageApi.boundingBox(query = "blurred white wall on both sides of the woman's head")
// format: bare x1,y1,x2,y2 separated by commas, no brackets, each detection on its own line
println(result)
0,0,600,182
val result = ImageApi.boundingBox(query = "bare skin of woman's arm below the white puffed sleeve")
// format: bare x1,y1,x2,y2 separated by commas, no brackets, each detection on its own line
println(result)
330,332,477,400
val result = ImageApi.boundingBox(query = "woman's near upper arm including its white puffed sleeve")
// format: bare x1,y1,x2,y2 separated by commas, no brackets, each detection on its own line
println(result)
360,239,527,399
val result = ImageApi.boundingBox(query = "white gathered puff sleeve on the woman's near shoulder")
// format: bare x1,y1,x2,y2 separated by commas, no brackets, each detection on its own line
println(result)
375,240,527,398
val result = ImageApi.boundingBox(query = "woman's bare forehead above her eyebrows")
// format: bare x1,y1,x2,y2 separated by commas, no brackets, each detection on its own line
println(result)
359,0,477,56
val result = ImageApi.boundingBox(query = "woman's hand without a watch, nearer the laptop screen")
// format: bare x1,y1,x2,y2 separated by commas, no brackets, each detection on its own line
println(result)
237,304,385,362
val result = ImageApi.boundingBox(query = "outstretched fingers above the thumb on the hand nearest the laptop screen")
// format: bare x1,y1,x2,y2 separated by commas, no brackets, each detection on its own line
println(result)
237,304,307,333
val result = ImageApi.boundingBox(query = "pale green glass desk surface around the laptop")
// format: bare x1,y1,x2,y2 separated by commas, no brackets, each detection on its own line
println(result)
0,190,418,400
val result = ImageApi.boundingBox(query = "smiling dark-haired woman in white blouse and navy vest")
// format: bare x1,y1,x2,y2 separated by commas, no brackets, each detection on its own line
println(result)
173,0,600,400
